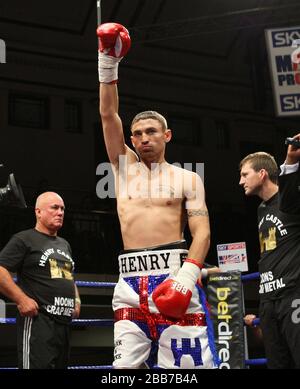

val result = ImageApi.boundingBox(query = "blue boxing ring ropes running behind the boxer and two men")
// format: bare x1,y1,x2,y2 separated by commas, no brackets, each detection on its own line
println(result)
0,273,267,370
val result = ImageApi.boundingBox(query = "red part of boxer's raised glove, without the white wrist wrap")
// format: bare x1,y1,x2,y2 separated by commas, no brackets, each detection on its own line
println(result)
97,23,131,58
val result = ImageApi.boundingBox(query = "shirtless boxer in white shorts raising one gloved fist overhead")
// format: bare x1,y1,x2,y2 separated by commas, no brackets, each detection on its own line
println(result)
97,23,216,369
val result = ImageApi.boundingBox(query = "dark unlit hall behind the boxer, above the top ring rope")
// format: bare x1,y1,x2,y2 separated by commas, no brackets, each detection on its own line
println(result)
0,0,300,274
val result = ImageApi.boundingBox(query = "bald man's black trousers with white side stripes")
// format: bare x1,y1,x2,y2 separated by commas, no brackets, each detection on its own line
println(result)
17,312,70,369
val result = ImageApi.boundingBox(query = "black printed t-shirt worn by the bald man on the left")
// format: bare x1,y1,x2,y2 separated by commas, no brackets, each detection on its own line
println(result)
0,229,75,324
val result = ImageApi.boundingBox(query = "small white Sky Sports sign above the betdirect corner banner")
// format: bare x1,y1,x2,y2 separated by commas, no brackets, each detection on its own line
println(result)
217,242,248,272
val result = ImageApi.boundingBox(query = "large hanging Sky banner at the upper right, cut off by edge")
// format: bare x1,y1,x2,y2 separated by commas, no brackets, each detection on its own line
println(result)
265,26,300,116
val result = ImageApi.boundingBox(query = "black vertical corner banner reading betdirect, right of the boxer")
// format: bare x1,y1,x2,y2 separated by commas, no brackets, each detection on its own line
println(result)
207,271,246,369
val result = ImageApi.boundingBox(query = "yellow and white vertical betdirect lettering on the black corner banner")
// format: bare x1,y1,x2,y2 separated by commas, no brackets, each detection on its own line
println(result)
217,288,232,369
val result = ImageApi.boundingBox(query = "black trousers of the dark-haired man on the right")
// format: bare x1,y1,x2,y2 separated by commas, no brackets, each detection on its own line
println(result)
259,289,300,369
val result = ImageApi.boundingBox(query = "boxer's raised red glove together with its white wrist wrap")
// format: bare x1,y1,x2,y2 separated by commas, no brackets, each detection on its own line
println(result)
97,23,131,84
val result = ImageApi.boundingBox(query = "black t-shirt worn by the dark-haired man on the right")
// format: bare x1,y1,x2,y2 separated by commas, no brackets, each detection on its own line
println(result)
258,170,300,301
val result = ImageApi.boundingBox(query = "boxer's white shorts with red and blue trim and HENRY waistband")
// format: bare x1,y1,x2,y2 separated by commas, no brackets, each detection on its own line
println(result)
113,244,217,369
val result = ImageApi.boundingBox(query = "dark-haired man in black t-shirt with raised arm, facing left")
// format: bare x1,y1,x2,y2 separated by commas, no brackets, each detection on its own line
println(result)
240,134,300,369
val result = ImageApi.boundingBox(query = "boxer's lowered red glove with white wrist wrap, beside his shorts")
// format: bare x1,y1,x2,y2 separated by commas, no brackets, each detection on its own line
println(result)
152,262,200,319
